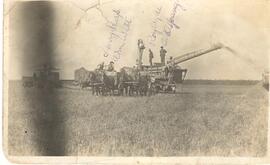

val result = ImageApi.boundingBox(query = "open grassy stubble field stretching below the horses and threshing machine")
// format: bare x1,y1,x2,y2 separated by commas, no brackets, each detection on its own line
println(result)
8,82,268,156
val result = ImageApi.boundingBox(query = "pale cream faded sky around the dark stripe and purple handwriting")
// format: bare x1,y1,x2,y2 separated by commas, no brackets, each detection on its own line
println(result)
5,0,270,79
